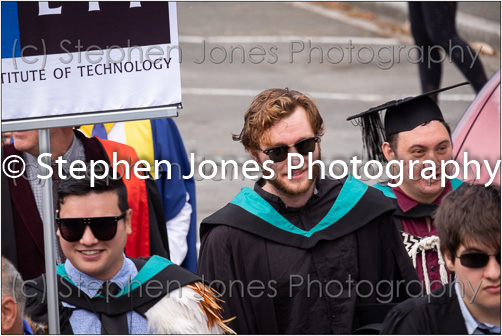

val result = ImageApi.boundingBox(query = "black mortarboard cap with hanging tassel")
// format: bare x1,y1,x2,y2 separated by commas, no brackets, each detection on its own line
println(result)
347,82,470,162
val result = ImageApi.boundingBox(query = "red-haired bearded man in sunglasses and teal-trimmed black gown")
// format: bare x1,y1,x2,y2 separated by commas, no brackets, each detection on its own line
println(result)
198,89,418,334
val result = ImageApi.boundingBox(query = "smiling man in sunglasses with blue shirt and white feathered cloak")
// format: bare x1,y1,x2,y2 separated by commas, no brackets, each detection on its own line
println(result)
25,177,231,335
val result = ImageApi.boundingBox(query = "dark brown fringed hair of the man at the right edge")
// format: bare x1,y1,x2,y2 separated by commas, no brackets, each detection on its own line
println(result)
434,183,500,262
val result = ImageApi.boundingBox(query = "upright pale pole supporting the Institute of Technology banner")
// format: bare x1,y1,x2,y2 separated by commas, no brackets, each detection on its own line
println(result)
38,129,60,335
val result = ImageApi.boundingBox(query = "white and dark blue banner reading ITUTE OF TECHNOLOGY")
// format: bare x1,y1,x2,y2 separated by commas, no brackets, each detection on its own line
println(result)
2,2,181,121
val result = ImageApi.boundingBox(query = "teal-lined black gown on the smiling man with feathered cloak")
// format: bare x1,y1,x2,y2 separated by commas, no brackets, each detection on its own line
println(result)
24,256,201,334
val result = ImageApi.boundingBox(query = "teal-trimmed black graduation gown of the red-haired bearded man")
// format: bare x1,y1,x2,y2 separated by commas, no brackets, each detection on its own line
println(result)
198,179,420,334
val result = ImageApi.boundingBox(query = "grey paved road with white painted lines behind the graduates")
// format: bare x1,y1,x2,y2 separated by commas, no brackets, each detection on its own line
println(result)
176,2,500,240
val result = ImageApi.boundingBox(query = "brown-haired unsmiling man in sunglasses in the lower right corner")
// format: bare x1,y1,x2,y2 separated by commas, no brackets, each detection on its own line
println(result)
382,184,500,335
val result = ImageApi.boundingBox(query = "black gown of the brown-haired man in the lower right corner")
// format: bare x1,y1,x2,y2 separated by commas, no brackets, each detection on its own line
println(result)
381,282,467,335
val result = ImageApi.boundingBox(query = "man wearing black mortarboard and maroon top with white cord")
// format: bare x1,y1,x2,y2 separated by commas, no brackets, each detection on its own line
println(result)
347,82,469,294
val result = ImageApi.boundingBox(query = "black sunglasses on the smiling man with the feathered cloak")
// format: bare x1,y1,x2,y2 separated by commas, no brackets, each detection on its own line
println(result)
56,211,126,242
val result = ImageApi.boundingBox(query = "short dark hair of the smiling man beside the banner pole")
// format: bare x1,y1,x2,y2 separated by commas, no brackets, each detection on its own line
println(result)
58,169,129,212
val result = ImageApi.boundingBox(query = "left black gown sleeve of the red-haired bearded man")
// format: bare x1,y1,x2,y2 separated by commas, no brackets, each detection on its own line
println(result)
198,225,277,334
